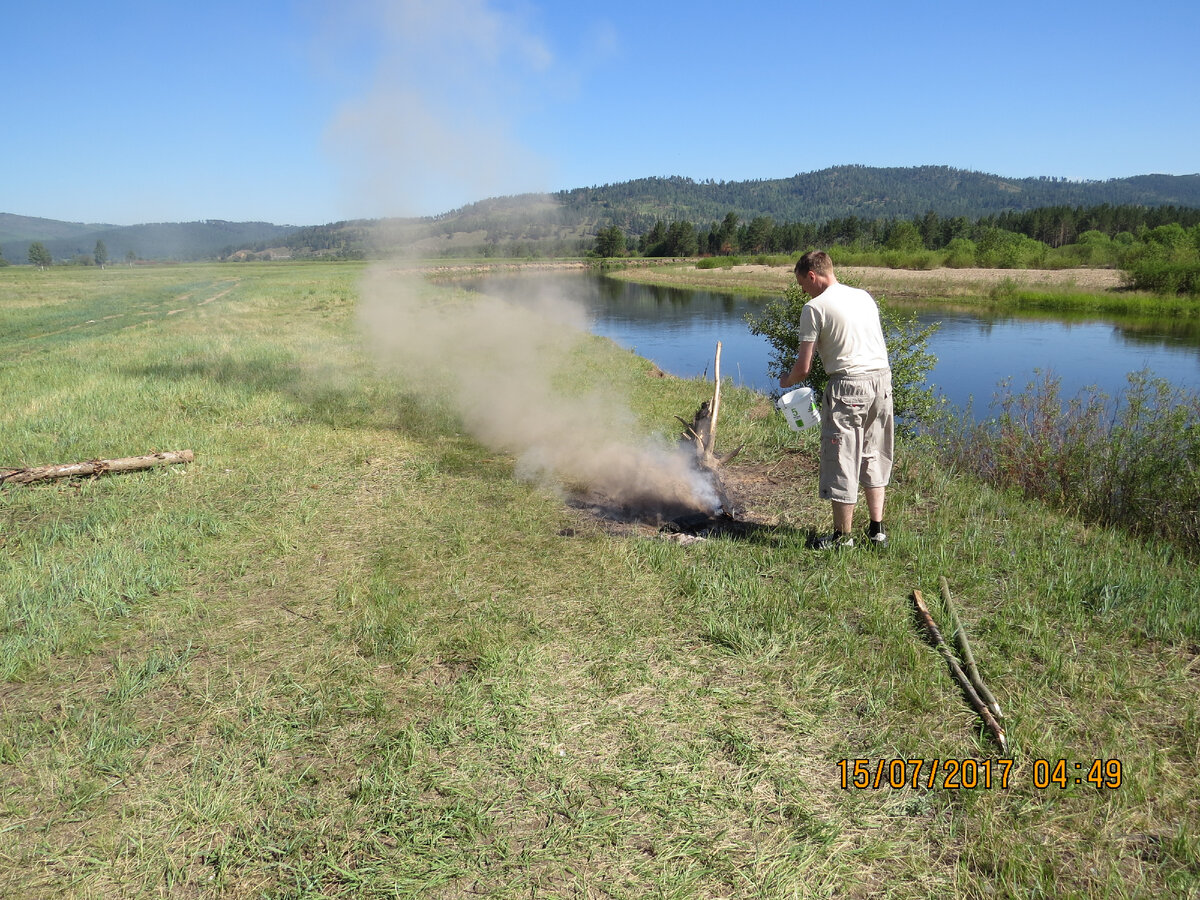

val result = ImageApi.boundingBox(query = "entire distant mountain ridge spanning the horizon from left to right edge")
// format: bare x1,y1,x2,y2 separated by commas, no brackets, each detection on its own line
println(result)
0,166,1200,263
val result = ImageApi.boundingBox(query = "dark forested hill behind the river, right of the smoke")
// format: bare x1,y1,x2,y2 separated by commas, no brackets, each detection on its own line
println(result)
557,166,1200,233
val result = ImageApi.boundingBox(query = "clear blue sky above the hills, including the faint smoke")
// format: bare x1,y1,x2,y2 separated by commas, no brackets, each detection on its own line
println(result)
0,0,1200,224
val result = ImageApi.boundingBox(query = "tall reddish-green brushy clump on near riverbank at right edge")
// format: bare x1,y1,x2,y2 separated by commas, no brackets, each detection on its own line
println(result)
940,372,1200,552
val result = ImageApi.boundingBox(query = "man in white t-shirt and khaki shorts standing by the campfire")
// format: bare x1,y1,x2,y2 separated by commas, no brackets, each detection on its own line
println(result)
779,250,894,550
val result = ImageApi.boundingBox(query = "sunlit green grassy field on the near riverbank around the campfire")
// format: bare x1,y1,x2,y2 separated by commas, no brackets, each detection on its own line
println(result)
0,256,1200,898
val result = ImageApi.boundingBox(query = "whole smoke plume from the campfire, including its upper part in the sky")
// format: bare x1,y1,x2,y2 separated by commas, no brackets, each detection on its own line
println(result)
330,0,718,510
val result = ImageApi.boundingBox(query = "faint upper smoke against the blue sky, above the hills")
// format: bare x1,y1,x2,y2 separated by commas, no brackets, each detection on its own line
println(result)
326,0,559,217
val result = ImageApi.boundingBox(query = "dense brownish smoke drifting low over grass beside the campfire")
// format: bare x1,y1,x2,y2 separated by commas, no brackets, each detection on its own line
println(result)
360,264,720,516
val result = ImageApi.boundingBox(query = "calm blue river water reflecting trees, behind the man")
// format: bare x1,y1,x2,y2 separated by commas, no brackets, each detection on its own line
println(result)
460,275,1200,412
